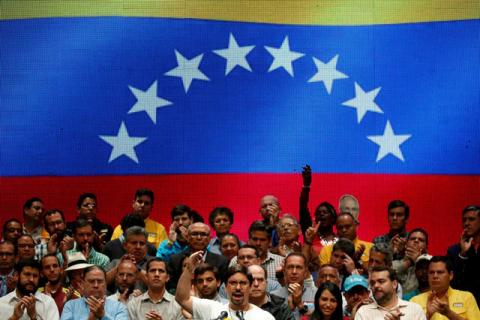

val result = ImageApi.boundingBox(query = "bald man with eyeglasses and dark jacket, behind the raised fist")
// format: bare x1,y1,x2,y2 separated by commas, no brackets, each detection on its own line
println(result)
167,222,228,292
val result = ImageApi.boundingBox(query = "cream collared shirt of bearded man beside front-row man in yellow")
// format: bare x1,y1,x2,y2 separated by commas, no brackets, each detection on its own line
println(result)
355,299,427,320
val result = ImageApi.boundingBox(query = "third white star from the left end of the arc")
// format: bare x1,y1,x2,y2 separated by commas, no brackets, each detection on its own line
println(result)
165,50,210,93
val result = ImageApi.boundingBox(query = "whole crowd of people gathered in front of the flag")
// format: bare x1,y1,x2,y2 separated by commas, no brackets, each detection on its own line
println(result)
0,166,480,320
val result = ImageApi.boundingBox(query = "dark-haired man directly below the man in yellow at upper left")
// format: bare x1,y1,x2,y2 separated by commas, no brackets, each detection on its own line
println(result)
105,227,152,291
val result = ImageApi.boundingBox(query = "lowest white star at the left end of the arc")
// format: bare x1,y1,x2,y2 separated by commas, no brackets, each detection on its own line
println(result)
99,121,147,163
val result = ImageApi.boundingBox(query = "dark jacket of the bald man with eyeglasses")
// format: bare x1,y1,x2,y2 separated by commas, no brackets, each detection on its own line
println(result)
167,249,228,294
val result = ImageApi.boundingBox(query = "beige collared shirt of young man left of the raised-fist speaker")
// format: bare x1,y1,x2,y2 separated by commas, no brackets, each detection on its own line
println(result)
127,290,182,320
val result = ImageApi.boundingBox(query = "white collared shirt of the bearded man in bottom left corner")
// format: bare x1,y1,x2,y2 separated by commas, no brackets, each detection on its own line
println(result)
0,290,59,320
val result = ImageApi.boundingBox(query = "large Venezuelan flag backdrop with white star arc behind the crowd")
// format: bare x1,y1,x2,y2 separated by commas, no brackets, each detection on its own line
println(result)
0,0,480,253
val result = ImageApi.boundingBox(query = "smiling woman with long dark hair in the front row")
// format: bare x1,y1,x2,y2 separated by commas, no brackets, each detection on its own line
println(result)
310,282,344,320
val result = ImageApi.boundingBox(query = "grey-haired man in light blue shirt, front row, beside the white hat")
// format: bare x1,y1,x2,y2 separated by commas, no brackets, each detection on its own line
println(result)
61,266,128,320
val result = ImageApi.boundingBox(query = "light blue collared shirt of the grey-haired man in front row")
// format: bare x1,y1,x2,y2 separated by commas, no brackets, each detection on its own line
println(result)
61,297,128,320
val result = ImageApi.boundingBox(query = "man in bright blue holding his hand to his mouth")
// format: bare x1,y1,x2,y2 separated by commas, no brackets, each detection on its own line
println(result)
157,204,193,263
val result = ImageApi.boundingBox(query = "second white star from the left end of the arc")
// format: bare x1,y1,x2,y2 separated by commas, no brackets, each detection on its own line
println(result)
128,80,172,124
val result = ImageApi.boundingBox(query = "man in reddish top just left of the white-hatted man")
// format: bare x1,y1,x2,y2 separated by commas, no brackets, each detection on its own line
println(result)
38,254,80,314
